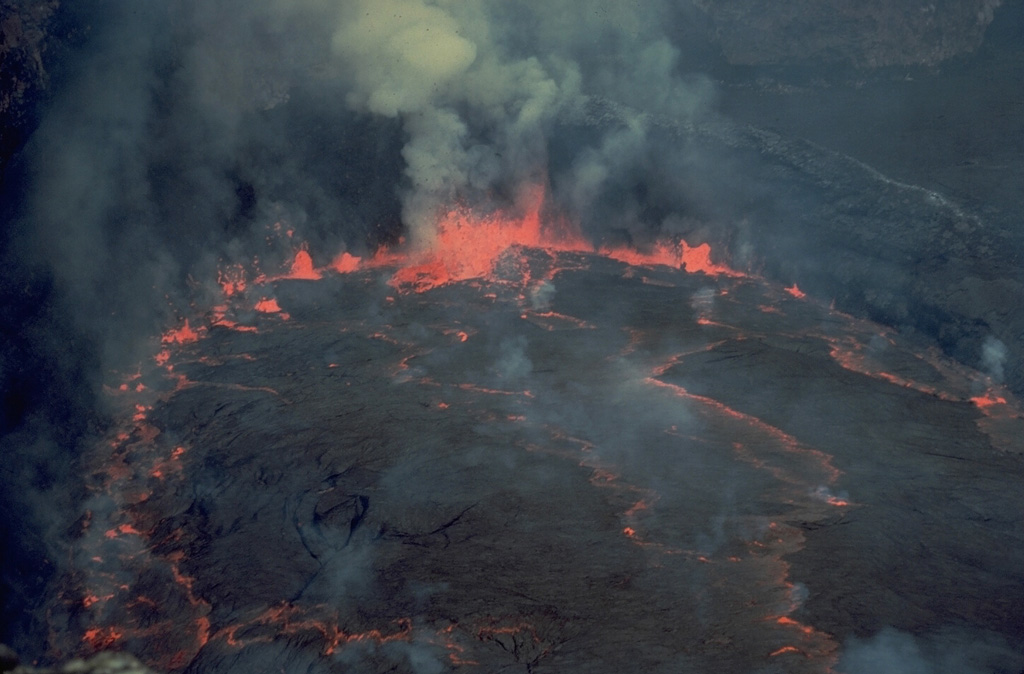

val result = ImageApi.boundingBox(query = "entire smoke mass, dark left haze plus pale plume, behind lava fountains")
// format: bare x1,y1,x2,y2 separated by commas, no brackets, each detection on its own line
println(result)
16,0,713,356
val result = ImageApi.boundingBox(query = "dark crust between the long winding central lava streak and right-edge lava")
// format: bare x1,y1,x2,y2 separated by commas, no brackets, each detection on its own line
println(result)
666,340,1024,635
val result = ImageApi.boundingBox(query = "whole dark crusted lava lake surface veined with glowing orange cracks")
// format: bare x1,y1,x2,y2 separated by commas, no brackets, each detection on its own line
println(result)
59,247,1024,673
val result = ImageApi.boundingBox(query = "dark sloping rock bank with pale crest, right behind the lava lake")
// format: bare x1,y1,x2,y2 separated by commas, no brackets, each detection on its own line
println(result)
622,114,1024,393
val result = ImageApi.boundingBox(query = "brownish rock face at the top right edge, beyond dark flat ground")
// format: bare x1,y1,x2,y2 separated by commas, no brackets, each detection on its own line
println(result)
695,0,1001,68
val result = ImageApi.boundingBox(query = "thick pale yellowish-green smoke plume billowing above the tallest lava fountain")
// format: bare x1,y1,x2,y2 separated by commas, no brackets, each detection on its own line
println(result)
319,0,707,244
